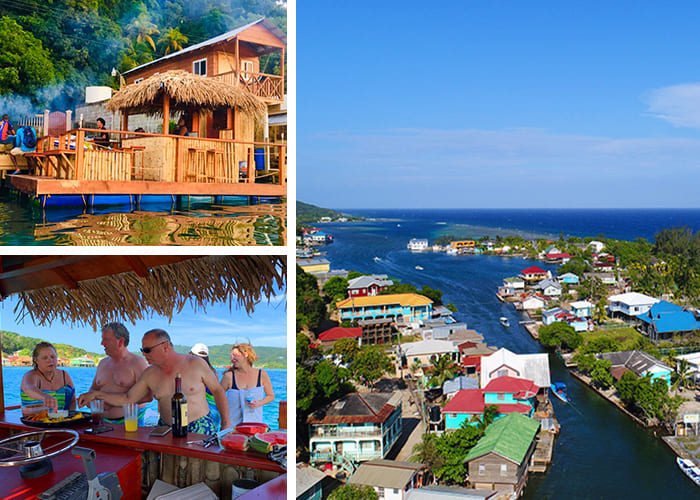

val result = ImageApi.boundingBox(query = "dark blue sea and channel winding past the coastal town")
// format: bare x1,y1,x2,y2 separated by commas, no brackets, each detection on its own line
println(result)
323,211,700,499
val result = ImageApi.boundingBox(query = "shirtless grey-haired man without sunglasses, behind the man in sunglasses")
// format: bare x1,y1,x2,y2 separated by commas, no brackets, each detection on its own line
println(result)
90,323,153,424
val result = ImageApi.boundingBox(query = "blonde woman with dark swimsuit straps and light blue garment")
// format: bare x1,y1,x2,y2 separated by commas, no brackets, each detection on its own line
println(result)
221,343,275,427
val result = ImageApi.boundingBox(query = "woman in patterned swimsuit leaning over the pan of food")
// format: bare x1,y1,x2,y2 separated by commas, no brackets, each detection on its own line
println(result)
20,342,75,410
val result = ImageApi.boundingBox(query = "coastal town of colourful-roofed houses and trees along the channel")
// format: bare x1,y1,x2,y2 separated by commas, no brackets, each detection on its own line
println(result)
297,223,700,499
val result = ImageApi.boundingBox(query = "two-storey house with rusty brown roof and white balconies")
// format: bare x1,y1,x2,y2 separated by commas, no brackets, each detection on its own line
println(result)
307,392,401,464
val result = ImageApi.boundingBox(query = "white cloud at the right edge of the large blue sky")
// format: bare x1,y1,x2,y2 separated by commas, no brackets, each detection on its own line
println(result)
645,83,700,128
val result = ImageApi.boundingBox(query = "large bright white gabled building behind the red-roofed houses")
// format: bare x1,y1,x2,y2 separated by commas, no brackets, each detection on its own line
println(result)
481,348,551,392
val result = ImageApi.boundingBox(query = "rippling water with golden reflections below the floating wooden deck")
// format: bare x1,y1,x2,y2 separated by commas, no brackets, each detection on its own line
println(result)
0,193,287,246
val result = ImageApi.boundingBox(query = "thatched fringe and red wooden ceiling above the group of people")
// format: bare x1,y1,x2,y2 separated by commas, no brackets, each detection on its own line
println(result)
0,255,287,330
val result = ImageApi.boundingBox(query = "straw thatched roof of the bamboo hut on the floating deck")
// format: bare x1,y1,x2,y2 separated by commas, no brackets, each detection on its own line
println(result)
107,70,267,120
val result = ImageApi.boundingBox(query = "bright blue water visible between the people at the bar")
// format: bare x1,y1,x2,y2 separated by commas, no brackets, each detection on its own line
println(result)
2,367,287,429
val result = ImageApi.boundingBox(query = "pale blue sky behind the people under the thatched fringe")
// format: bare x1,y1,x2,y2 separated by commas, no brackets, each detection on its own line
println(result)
0,293,287,354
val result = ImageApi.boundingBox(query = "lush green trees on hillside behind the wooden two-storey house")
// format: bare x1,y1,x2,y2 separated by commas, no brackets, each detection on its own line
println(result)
0,0,287,110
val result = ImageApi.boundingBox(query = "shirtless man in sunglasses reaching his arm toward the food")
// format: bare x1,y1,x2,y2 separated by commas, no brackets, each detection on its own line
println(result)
78,329,231,435
